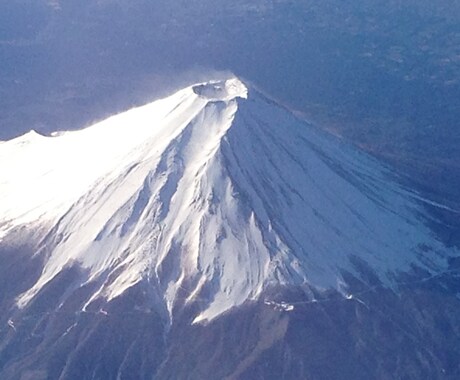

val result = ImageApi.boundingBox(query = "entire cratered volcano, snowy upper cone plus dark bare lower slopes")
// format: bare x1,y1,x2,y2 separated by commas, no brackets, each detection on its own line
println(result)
0,78,460,380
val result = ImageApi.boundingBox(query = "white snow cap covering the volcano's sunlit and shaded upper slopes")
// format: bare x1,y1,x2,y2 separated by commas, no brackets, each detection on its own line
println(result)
0,79,448,322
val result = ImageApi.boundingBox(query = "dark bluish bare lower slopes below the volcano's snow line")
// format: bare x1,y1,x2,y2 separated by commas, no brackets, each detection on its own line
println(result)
0,254,460,380
